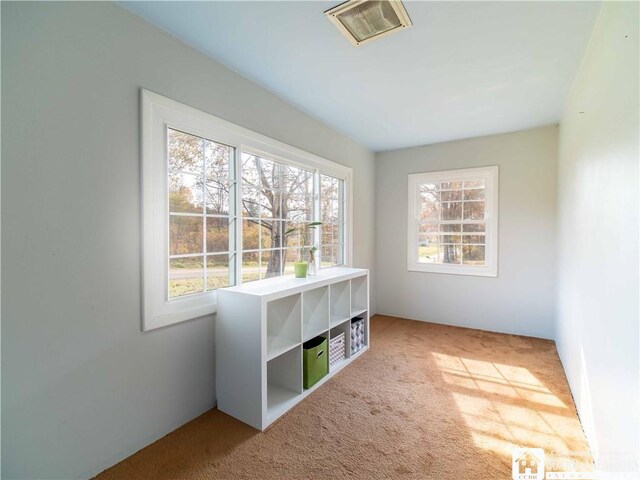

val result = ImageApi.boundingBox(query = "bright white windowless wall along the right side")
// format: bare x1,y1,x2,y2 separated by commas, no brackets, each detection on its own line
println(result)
557,2,640,478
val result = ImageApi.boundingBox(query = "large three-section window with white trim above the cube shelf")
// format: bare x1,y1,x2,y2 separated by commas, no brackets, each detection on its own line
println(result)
142,90,352,330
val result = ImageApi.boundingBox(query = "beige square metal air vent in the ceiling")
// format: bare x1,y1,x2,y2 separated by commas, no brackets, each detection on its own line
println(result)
324,0,413,47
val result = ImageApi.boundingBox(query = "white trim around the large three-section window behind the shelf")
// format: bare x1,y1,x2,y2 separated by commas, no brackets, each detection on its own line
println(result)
141,89,353,331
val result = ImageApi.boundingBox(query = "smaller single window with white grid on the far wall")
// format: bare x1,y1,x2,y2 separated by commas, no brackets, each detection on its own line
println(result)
407,167,498,276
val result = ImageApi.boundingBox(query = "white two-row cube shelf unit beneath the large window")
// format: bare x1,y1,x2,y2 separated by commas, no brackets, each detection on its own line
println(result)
216,267,369,430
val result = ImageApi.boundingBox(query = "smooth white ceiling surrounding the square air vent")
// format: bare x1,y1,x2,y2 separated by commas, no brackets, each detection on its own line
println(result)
121,0,600,151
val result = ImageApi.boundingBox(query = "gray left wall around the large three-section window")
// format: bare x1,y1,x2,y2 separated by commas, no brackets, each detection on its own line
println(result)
2,2,375,478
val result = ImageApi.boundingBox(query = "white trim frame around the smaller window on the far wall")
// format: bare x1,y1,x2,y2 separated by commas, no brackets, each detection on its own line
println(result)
407,166,499,277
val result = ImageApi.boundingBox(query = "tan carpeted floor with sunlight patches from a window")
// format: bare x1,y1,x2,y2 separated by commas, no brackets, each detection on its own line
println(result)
97,316,591,480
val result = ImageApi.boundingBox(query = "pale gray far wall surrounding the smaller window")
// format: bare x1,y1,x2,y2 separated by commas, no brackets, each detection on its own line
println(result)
376,126,558,338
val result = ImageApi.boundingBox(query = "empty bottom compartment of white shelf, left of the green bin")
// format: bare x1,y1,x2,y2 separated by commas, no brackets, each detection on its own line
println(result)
267,345,302,420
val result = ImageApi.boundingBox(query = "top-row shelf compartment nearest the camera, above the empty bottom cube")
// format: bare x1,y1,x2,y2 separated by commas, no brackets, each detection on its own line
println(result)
267,293,302,360
